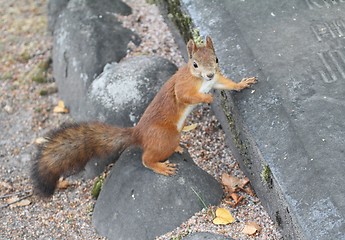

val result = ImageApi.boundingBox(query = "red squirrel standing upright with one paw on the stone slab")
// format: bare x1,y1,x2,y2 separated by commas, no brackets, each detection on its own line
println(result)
32,36,256,197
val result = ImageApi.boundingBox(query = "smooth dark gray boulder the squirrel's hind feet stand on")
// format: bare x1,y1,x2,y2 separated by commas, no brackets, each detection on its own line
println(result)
92,148,223,240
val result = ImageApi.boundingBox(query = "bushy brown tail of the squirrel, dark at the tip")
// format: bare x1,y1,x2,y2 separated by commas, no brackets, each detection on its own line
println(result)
32,122,135,197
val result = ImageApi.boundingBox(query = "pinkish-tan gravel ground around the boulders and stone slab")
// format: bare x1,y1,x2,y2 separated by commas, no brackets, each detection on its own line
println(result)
0,0,281,240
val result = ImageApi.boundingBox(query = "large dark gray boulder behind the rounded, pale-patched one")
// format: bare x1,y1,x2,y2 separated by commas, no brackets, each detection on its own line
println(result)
53,0,140,120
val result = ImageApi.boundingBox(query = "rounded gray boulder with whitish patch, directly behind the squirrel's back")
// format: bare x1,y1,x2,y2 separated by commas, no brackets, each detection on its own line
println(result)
88,56,177,127
